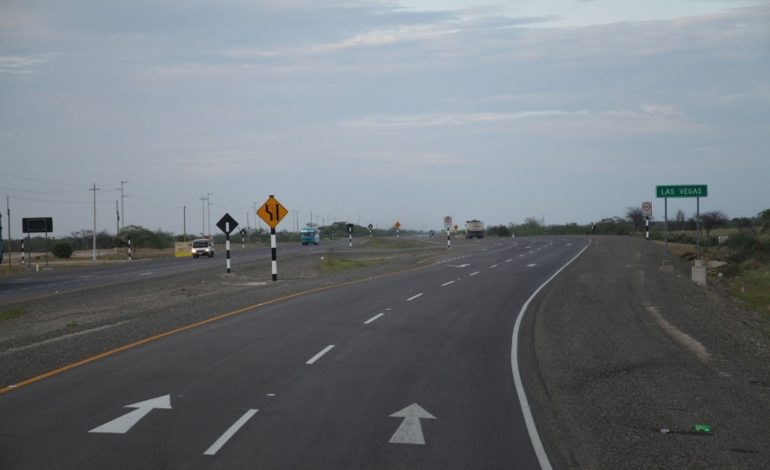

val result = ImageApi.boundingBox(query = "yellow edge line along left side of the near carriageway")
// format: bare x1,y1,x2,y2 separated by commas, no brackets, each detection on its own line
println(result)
0,265,426,395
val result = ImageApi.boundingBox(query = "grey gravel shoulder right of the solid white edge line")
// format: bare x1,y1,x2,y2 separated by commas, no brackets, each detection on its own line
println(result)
522,237,770,469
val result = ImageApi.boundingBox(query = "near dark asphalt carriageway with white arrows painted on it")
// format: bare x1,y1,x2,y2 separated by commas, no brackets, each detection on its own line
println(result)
0,238,589,470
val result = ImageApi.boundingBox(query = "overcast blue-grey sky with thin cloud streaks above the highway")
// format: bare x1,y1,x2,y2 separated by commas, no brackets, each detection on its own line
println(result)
0,0,770,237
